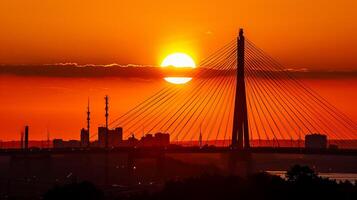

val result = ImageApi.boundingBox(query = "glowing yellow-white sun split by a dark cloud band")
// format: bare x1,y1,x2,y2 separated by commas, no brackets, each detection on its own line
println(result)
161,53,196,84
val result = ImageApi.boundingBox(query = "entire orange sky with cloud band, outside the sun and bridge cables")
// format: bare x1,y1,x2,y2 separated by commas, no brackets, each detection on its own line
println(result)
0,0,357,140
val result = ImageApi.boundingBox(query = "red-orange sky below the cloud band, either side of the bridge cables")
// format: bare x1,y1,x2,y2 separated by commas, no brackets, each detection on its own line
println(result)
0,76,357,141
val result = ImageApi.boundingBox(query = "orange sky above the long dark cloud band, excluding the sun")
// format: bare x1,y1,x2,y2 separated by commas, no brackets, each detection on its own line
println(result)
0,0,357,69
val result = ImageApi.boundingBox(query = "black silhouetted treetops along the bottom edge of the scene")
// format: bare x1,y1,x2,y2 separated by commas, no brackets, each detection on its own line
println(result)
43,165,357,200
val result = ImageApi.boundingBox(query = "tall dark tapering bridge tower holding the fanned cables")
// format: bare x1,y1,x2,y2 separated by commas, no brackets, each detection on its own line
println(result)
232,29,250,149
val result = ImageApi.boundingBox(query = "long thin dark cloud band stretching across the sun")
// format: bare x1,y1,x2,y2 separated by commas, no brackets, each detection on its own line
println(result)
0,63,357,79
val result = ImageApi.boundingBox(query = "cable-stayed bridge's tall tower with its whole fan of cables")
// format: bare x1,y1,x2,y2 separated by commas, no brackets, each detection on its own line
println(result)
109,30,357,149
